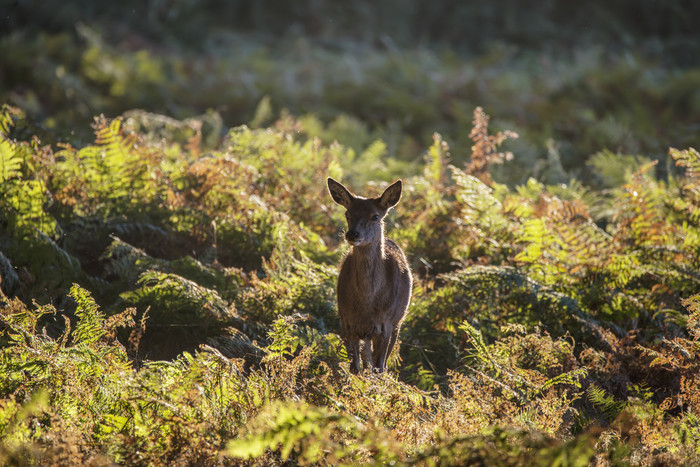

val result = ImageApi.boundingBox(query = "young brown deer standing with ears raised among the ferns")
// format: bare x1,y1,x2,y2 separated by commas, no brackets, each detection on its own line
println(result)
328,178,412,374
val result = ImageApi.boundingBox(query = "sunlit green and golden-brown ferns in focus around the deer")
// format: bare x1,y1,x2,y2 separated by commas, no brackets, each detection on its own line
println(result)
0,105,700,465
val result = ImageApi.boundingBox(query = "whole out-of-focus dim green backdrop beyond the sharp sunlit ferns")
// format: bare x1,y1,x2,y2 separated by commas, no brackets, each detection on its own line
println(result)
0,0,700,187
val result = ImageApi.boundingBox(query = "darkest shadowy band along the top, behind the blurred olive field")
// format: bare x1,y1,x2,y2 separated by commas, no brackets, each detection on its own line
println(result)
5,0,700,65
